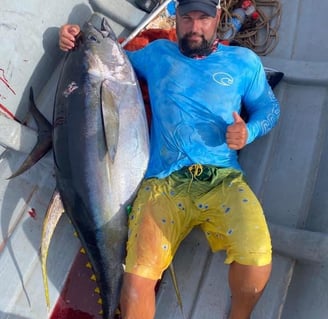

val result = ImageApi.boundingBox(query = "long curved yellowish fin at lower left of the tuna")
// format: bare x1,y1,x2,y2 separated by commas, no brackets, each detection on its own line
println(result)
41,191,64,310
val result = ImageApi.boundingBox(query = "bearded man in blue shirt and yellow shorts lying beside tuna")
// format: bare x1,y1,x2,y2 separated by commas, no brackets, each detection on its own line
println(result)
59,0,279,319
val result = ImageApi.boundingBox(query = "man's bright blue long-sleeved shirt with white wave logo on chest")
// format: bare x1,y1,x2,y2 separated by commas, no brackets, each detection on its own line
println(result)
127,40,280,178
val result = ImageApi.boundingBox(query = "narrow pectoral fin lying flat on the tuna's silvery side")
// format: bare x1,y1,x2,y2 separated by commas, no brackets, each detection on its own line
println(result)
101,80,120,162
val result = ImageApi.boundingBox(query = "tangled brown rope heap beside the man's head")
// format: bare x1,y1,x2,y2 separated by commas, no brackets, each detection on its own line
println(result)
218,0,281,55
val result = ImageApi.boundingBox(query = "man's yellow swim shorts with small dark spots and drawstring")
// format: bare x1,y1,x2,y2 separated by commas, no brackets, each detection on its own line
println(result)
125,165,272,280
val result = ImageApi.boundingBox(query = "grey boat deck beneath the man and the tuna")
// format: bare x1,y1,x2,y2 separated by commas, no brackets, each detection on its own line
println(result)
0,0,328,319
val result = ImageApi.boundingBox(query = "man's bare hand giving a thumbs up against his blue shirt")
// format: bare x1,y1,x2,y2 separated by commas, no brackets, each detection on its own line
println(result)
226,112,248,150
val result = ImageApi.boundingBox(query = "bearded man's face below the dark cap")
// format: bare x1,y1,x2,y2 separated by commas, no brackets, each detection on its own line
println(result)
176,10,220,56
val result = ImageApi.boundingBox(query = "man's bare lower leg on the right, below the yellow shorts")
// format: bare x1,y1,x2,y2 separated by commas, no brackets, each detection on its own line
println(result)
229,262,271,319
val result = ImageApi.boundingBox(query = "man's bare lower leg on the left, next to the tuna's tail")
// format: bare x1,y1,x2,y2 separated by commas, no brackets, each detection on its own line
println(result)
120,273,157,319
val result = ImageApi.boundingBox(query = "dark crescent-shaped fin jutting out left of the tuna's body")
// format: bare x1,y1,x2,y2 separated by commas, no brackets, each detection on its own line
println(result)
8,87,52,179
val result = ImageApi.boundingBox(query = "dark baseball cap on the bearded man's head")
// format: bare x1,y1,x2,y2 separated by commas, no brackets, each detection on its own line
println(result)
177,0,220,17
